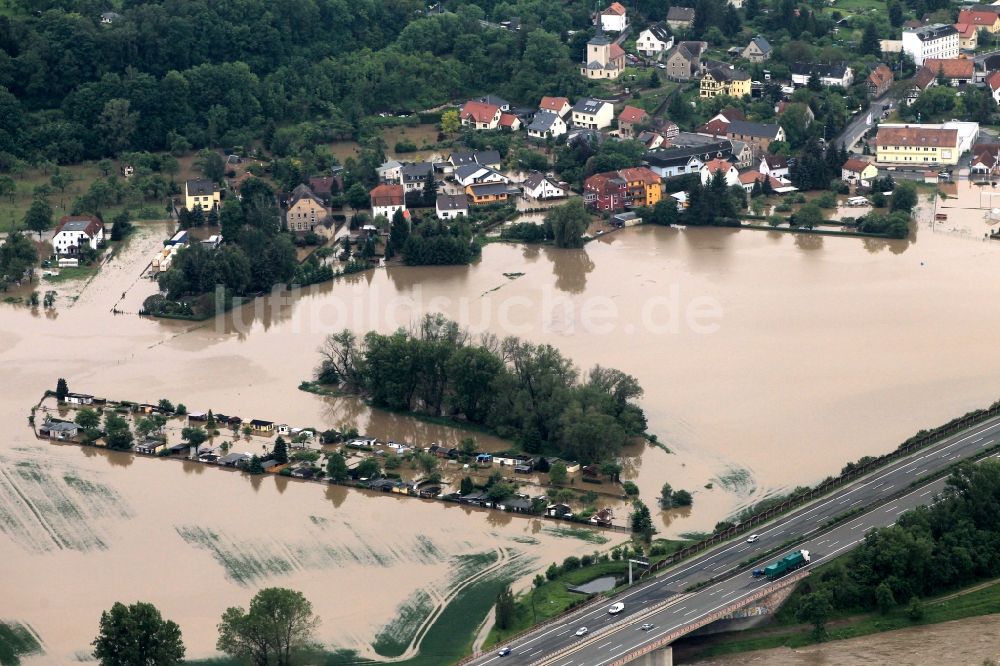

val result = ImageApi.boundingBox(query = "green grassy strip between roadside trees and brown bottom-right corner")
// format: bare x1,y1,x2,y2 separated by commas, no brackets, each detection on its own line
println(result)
684,564,1000,660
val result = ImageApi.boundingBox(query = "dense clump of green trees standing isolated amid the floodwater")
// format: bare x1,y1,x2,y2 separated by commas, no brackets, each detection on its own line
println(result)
316,315,646,463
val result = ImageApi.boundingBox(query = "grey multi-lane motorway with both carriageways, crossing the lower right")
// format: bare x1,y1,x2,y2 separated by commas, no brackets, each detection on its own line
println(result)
464,418,1000,666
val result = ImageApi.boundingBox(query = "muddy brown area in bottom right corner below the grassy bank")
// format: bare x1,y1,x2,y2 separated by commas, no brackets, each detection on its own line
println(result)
690,615,1000,666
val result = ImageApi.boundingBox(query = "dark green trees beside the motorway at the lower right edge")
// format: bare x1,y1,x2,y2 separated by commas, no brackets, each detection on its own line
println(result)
791,459,1000,630
